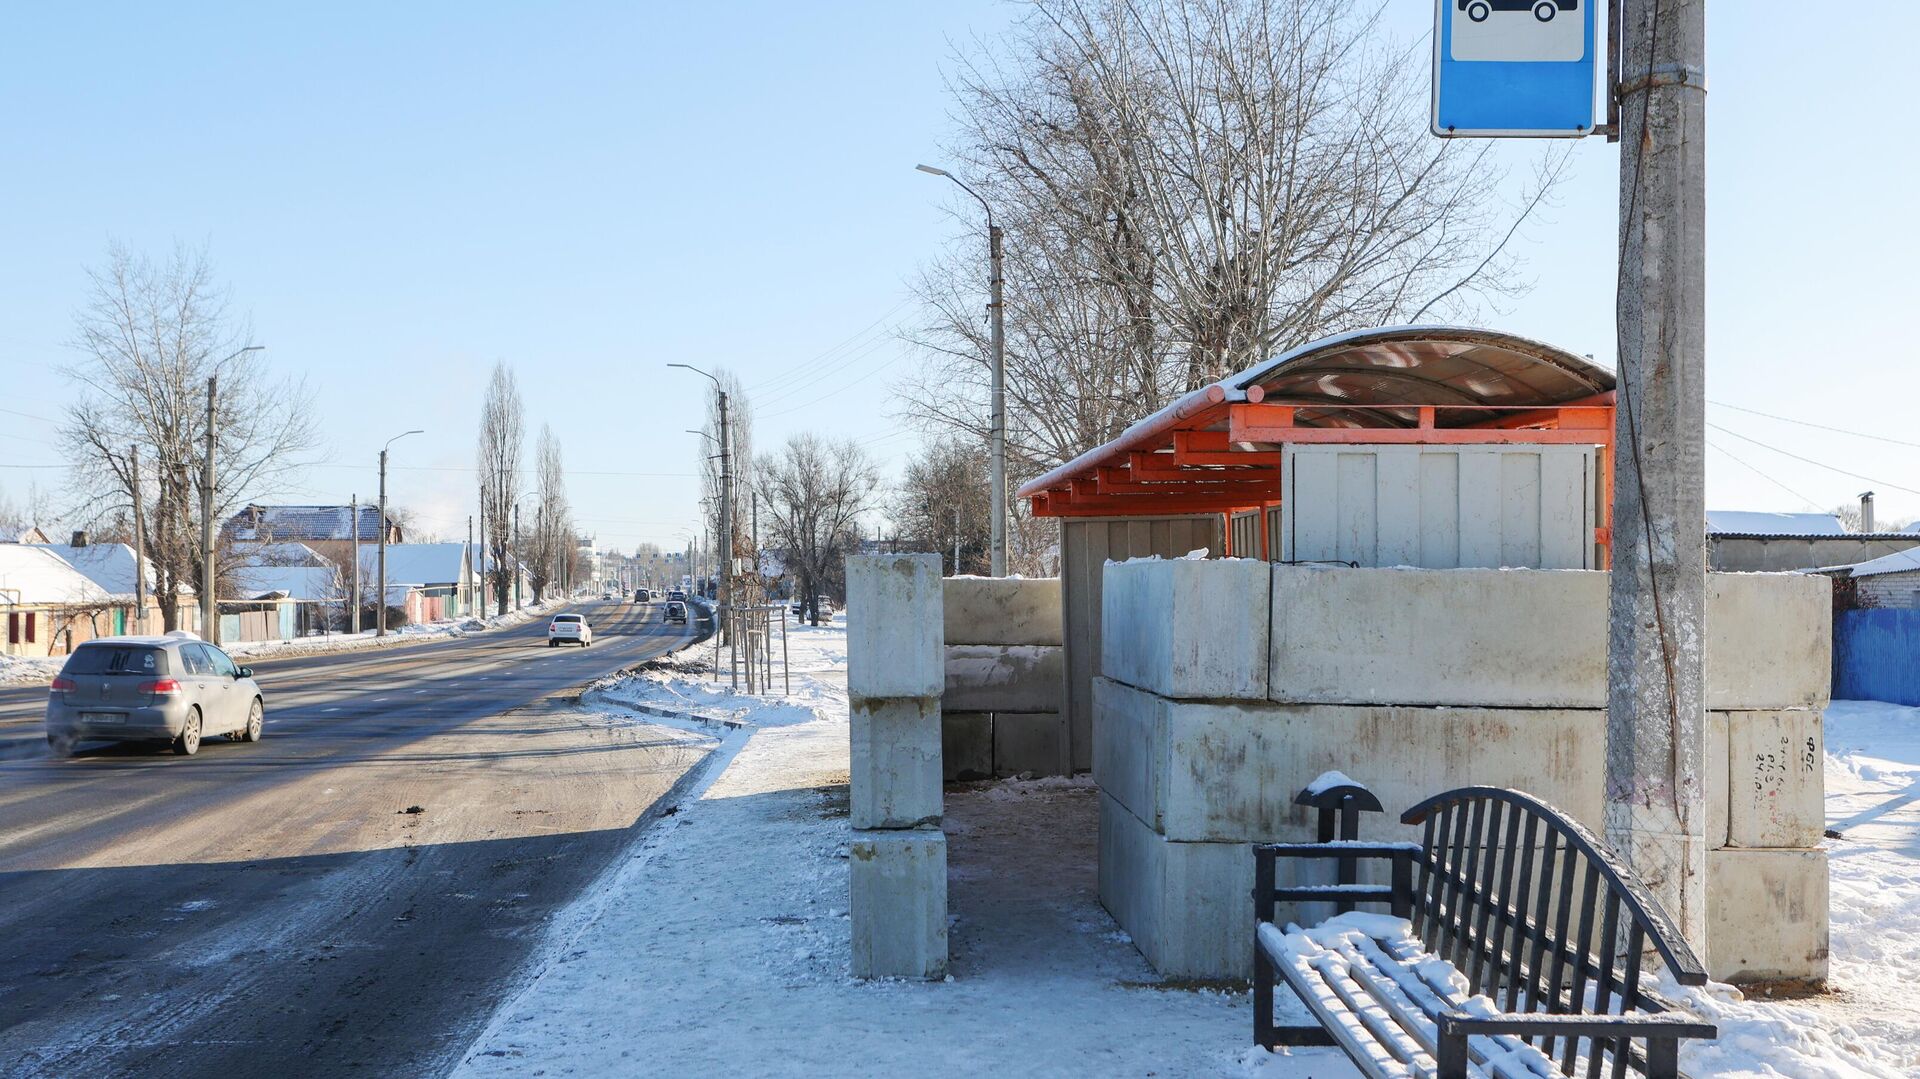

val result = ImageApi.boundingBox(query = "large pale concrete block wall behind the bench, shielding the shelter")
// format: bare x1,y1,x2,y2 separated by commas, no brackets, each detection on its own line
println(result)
1092,561,1832,979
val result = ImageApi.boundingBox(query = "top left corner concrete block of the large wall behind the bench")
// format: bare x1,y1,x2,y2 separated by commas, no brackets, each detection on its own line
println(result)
1100,559,1271,701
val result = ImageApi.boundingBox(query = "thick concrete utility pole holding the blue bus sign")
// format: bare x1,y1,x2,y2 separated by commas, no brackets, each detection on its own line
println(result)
1607,0,1711,962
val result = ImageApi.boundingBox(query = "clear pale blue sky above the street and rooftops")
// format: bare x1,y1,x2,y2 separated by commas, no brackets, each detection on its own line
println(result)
0,0,1920,547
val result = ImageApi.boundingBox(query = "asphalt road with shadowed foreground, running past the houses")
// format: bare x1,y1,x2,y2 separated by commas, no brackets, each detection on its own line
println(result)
0,603,710,1079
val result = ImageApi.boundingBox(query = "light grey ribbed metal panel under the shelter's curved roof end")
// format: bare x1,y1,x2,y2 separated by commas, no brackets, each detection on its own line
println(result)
1273,445,1599,570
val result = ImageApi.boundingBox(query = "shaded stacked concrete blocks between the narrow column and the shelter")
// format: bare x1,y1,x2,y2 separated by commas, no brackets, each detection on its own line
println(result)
941,578,1073,779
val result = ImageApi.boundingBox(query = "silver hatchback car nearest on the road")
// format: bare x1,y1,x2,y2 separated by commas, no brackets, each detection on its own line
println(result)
46,635,267,756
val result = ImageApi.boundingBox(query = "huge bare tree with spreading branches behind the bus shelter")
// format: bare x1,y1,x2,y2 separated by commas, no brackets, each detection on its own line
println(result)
906,0,1567,476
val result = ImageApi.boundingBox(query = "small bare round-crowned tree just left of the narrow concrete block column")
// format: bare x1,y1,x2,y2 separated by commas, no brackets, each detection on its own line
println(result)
758,434,879,626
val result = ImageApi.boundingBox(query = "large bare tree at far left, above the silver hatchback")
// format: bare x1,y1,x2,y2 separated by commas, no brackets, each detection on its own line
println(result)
61,244,319,630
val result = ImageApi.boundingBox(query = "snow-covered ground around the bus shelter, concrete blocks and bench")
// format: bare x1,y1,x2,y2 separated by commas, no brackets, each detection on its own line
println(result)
457,622,1920,1079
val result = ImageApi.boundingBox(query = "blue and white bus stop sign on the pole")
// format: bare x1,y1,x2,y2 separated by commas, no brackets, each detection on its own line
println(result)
1432,0,1599,138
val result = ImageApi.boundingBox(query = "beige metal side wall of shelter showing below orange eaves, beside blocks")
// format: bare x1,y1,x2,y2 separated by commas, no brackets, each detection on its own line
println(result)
1060,515,1223,772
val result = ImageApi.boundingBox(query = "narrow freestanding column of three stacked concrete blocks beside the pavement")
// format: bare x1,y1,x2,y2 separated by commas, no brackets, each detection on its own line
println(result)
847,555,947,977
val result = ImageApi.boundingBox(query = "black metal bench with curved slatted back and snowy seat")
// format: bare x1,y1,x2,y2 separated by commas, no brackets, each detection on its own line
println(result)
1254,776,1716,1079
